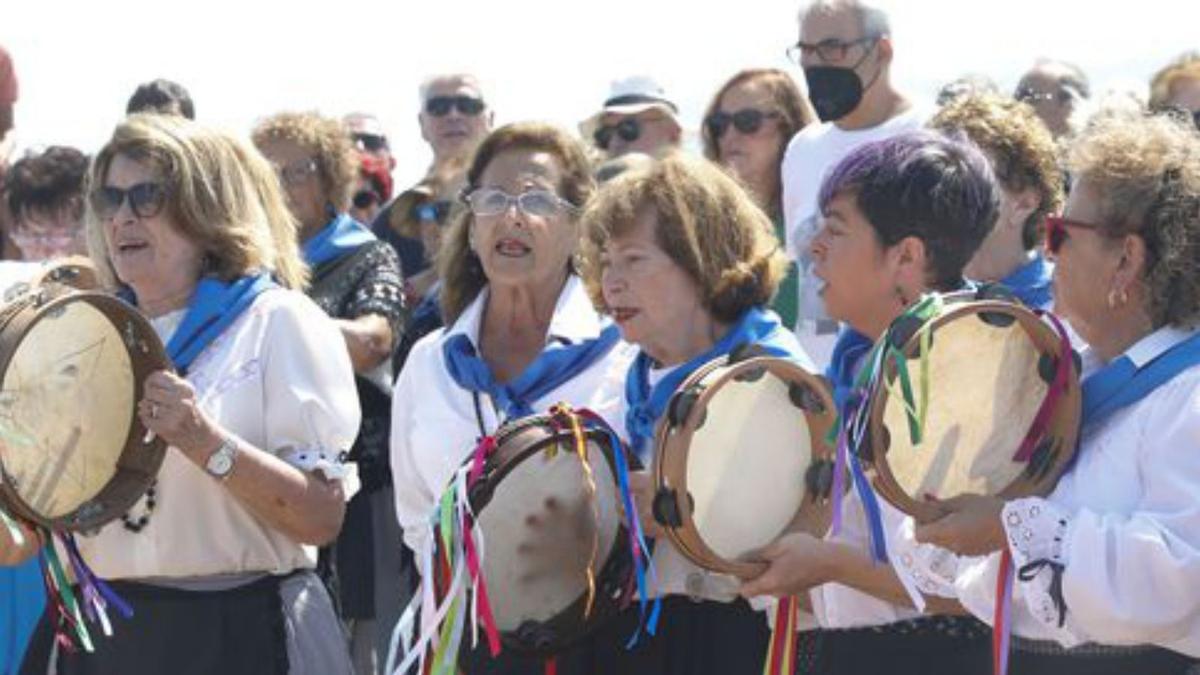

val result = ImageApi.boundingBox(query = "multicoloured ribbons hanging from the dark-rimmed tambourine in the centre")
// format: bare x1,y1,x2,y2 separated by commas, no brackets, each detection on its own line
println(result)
386,405,658,675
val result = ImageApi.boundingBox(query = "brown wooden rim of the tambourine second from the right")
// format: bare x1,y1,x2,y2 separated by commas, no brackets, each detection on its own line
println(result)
653,357,835,577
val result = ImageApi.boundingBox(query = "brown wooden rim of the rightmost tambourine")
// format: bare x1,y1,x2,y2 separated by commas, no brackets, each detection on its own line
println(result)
864,300,1082,522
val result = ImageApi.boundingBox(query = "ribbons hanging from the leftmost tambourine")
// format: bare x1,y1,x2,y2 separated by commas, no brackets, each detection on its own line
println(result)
0,509,133,652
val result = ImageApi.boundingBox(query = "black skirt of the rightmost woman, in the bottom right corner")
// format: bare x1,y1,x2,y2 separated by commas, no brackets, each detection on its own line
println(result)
1008,638,1198,675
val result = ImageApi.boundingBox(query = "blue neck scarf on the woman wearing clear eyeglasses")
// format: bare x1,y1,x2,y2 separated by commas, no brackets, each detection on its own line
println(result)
442,312,620,419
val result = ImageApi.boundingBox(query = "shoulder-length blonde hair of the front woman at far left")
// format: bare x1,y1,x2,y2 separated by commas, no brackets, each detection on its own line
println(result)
88,114,308,288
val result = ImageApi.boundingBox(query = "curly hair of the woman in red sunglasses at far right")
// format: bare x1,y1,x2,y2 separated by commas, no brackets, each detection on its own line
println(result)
1068,110,1200,328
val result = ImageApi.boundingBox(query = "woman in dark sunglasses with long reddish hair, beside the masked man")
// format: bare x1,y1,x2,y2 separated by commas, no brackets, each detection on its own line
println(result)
701,68,816,327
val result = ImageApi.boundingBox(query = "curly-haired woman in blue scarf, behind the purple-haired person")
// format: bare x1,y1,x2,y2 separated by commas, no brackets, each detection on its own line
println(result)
929,94,1063,309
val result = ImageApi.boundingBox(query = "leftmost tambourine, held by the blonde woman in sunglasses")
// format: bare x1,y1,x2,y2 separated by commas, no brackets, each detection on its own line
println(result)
0,292,168,530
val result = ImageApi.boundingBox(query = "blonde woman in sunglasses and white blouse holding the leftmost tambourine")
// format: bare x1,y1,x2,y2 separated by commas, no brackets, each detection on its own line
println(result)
0,115,359,675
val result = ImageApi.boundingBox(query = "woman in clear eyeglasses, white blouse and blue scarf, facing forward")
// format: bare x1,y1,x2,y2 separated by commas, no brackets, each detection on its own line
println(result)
391,124,634,675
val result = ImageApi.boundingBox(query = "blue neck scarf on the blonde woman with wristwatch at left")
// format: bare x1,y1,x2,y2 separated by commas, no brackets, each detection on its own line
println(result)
120,273,277,375
